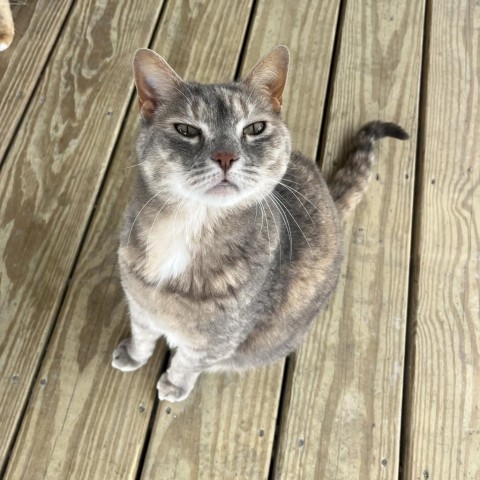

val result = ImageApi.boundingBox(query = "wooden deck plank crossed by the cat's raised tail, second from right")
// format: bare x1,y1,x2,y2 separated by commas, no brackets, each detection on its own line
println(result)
274,0,424,480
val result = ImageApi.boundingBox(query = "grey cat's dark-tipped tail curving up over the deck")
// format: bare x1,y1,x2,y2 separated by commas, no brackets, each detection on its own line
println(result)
328,120,408,216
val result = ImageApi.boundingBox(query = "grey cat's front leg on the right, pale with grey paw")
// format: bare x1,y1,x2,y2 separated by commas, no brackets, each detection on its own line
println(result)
157,346,233,402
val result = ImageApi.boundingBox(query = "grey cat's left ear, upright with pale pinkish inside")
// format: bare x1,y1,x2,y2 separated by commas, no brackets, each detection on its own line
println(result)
133,48,183,120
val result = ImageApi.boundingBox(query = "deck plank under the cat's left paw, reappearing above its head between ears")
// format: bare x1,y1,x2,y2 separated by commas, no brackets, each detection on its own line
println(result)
3,0,255,480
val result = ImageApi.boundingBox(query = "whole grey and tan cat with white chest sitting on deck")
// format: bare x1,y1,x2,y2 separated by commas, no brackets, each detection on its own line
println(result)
112,46,408,402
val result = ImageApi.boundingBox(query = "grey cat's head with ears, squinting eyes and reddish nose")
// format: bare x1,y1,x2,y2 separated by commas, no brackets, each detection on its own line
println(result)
133,46,290,207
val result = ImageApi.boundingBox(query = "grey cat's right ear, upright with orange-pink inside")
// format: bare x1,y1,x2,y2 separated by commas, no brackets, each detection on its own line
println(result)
245,45,290,112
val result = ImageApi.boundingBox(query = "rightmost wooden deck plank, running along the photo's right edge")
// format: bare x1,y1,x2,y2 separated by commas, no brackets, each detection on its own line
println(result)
404,0,480,479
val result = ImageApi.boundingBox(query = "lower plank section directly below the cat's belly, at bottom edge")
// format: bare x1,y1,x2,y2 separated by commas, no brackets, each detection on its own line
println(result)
142,365,283,480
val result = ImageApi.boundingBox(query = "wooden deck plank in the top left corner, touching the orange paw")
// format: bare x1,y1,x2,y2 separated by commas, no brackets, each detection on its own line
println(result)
0,0,73,165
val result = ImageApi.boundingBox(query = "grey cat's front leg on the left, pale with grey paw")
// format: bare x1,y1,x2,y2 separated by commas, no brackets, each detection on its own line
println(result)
112,293,162,372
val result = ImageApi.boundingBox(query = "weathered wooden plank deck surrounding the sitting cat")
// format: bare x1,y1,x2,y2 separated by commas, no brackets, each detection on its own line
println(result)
0,0,480,480
